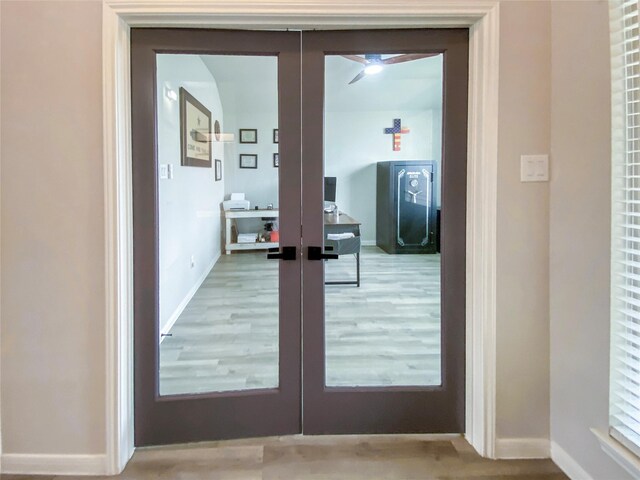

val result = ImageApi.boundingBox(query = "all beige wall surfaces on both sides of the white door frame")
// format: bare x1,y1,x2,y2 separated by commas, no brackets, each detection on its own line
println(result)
0,1,624,478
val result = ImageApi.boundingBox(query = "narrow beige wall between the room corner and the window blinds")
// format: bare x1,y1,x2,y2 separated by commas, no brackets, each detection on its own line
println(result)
549,1,630,480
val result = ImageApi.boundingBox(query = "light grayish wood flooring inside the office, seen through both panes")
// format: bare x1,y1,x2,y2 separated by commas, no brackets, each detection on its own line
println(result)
160,247,440,395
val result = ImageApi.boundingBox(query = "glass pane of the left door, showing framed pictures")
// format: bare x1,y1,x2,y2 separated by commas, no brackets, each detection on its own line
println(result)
156,54,280,395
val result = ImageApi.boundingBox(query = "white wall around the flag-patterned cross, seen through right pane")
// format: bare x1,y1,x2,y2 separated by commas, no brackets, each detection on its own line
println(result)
324,110,442,244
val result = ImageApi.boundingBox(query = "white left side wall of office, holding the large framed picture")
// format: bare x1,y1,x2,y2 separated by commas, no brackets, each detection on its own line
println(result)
157,55,225,333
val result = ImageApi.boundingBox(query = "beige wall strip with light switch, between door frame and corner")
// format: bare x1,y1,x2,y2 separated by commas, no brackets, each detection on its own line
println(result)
496,1,551,438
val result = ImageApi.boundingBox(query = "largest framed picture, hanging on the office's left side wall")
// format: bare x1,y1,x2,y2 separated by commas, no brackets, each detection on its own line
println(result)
180,87,211,168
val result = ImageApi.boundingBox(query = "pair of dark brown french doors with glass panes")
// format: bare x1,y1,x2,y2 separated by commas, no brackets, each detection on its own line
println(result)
131,29,468,446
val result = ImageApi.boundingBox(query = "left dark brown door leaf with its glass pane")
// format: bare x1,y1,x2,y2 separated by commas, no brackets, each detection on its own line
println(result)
131,29,302,446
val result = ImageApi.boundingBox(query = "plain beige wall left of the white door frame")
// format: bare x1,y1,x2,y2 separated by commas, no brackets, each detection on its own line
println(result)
0,1,106,454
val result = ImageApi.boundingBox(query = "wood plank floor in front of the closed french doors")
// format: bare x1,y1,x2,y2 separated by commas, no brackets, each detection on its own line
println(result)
0,435,568,480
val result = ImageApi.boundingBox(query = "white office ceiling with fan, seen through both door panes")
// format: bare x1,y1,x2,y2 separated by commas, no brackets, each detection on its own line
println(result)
201,55,442,112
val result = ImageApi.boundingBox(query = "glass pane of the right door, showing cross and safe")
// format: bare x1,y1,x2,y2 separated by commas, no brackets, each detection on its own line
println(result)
324,52,443,387
